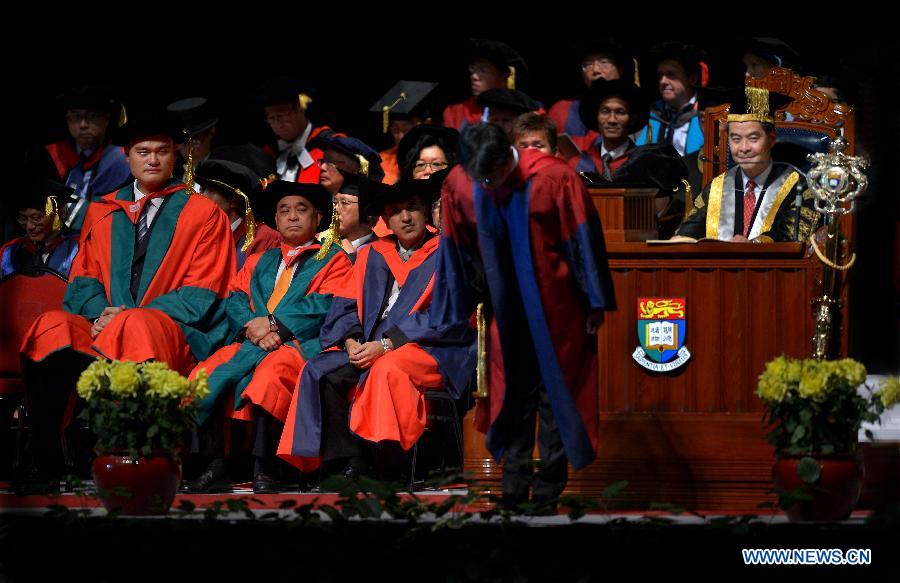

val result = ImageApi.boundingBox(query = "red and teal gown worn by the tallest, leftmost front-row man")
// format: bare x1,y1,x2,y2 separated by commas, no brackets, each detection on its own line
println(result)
22,181,235,374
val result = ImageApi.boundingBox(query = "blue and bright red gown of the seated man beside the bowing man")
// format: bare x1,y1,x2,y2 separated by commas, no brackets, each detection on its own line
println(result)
278,235,475,471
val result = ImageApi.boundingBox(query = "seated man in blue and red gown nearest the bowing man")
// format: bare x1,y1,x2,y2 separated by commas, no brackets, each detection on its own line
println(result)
278,173,474,478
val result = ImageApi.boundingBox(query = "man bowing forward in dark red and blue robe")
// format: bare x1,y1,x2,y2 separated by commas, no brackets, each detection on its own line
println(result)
430,124,615,511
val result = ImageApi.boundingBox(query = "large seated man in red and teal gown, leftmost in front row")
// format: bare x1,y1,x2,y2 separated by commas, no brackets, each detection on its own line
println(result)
21,113,234,486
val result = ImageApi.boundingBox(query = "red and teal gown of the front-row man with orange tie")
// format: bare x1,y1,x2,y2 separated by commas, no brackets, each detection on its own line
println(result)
191,243,351,423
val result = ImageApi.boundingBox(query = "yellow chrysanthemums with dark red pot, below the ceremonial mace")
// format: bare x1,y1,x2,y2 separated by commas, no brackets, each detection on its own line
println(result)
756,356,900,520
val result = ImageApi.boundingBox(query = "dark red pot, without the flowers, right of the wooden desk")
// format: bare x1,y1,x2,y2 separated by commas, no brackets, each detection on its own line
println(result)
772,454,864,522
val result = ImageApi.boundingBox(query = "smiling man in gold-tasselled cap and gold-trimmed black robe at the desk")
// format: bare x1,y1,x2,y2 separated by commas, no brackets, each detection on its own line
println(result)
673,87,818,243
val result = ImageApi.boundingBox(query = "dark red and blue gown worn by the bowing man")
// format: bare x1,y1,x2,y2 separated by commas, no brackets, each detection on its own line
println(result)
430,150,615,469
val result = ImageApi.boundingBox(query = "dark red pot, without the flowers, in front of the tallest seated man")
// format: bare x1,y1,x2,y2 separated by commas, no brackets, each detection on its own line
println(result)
91,452,181,516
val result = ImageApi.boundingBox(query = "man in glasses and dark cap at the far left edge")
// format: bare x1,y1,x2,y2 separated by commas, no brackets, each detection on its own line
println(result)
0,176,78,278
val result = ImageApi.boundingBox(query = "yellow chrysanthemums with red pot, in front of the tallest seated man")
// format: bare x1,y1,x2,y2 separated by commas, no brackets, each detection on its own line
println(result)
77,360,209,515
